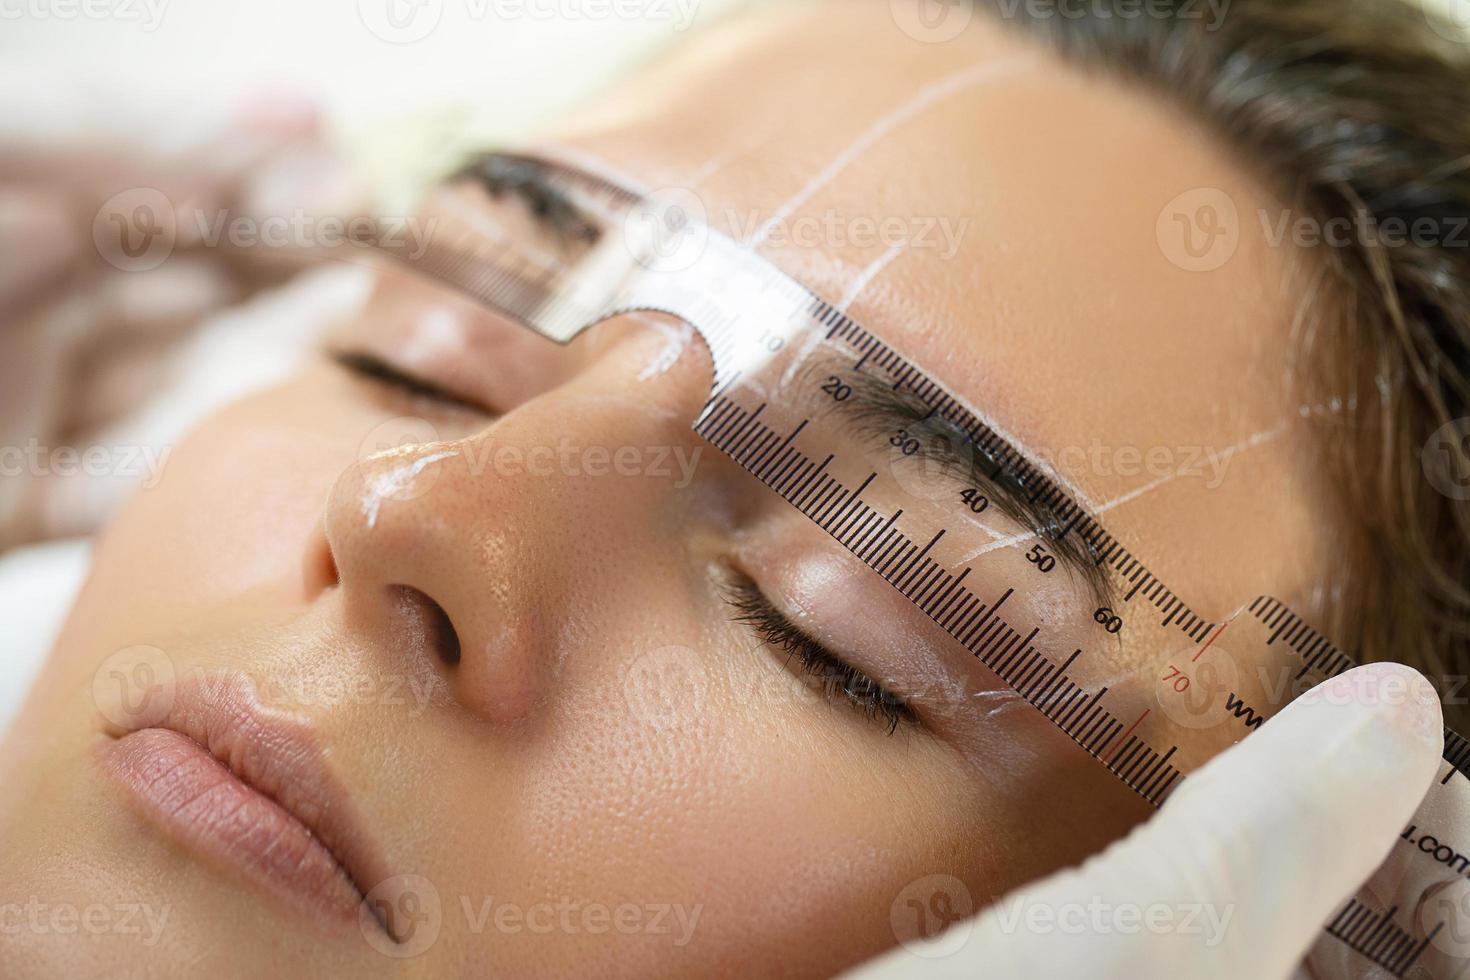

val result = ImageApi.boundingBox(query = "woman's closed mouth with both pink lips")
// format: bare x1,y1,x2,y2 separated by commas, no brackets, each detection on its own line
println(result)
101,677,387,932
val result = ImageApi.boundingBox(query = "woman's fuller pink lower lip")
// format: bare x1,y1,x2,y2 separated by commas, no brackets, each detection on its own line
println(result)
104,729,362,918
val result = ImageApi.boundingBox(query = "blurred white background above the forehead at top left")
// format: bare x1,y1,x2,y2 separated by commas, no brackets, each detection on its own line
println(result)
0,0,739,143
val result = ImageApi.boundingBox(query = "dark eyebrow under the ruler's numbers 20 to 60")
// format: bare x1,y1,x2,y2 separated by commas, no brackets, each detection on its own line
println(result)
800,351,1113,604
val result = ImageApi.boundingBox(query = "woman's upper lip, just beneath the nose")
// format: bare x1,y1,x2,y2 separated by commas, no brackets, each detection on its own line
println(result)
109,671,387,934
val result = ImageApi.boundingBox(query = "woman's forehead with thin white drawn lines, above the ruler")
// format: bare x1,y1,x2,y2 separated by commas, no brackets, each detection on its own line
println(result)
538,3,1323,613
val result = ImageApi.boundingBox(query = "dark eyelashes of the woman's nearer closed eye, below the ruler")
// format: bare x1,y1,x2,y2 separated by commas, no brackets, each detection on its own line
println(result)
725,576,917,735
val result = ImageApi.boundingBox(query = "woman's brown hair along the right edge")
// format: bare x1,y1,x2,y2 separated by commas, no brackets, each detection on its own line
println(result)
979,0,1470,719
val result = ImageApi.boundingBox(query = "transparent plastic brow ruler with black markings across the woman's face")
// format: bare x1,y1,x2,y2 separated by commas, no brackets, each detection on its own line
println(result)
364,154,1470,979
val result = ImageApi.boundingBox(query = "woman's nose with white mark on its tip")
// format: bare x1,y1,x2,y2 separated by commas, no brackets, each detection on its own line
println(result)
323,318,709,723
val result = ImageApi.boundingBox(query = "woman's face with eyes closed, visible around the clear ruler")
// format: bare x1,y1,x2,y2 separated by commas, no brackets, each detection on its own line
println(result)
0,3,1323,976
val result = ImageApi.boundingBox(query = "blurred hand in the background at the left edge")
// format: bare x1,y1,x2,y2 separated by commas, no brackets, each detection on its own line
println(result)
0,72,366,551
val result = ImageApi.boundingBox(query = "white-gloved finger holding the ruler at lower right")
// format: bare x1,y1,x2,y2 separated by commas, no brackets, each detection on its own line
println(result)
851,664,1444,980
